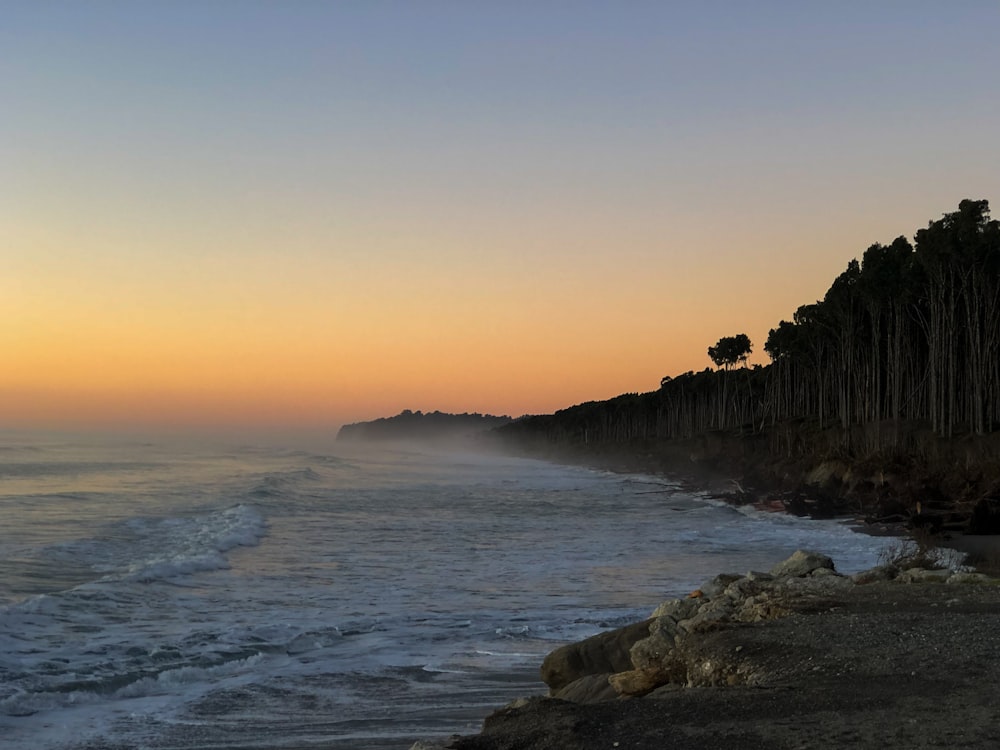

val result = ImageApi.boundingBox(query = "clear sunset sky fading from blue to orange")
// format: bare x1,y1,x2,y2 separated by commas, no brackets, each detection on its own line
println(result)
0,0,1000,429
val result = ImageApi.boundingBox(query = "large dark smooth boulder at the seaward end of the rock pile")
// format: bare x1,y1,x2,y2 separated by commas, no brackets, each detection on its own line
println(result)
541,620,653,691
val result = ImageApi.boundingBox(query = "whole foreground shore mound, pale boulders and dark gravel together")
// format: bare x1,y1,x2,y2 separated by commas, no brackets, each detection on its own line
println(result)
414,551,1000,750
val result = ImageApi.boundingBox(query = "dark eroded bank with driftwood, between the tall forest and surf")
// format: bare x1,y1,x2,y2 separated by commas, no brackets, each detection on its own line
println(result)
498,423,1000,534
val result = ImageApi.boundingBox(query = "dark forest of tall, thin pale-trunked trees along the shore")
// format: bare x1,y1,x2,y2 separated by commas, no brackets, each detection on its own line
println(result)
499,200,1000,462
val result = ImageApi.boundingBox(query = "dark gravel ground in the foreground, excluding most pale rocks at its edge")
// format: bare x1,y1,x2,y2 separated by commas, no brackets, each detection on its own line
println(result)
428,560,1000,750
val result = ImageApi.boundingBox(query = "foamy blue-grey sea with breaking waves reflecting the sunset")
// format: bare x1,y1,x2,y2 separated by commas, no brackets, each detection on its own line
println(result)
0,435,885,750
